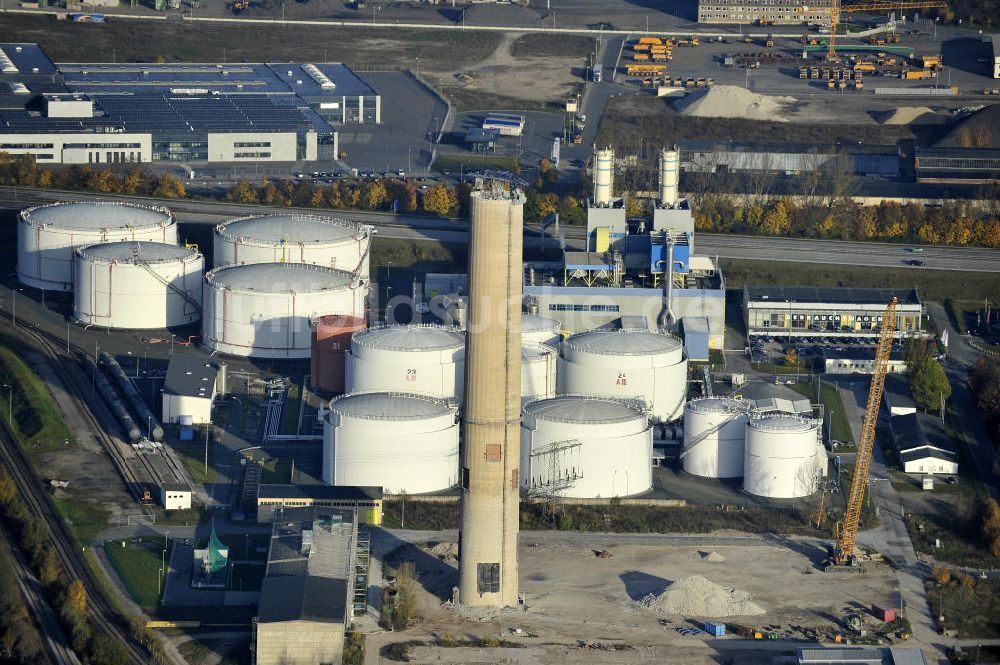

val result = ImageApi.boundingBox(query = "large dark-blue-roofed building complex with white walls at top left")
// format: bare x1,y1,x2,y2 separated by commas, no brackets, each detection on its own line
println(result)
0,43,381,164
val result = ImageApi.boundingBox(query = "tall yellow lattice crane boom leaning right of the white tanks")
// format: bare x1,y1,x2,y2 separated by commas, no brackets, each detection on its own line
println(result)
826,298,896,570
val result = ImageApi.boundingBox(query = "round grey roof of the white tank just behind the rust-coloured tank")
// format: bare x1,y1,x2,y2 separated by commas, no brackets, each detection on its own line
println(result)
205,263,355,293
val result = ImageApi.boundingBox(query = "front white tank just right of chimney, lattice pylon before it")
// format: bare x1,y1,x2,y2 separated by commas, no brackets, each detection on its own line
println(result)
521,395,653,498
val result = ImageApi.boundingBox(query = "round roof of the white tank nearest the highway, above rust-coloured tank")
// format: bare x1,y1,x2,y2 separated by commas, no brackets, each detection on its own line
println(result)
215,213,371,245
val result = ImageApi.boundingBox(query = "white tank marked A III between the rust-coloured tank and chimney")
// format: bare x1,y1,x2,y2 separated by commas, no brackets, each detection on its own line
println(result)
345,325,465,396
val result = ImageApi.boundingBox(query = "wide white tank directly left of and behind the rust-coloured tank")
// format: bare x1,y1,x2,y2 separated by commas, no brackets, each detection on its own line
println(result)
202,263,367,358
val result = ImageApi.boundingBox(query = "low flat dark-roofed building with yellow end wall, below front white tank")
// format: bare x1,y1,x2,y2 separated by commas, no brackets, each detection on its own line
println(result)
257,484,382,524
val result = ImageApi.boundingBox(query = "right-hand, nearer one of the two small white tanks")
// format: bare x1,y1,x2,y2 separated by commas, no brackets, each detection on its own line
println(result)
743,415,818,499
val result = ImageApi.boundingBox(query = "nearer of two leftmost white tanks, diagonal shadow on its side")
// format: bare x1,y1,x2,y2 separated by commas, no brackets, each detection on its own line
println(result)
73,241,205,329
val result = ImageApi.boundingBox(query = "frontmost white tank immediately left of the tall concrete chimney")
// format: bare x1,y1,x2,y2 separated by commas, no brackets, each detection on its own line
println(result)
323,393,459,494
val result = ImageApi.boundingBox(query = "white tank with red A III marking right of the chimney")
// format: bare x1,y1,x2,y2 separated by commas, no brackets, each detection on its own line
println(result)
559,330,687,423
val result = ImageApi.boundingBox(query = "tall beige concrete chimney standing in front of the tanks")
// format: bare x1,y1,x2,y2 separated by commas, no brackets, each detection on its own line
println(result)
459,185,524,607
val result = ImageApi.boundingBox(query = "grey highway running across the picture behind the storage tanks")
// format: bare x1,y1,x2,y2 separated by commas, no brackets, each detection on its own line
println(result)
0,187,1000,272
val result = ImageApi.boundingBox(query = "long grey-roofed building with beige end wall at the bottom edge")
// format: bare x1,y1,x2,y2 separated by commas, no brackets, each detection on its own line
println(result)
251,506,358,665
